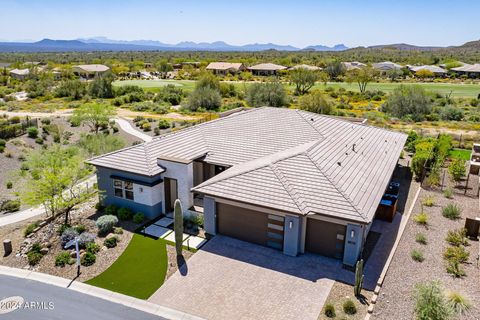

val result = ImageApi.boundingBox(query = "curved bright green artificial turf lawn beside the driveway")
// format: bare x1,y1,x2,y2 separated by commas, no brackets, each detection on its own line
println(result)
85,234,168,299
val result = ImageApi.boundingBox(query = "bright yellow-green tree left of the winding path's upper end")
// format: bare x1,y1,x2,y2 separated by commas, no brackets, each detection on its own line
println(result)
70,103,115,133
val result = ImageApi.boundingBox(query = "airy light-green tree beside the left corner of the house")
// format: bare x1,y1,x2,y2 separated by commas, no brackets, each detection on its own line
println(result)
21,144,92,223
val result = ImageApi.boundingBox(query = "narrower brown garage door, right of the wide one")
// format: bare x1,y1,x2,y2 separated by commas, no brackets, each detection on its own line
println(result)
305,218,346,259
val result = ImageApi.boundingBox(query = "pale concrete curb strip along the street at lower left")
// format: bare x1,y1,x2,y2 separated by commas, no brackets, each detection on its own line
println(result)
0,266,204,320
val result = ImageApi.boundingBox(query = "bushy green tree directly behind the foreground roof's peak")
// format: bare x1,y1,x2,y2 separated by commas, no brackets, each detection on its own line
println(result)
246,81,288,107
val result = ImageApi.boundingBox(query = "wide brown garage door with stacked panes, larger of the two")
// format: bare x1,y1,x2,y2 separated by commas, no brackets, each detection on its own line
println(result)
217,202,284,250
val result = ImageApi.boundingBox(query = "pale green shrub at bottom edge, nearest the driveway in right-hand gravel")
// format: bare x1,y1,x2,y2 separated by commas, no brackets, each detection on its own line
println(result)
414,281,451,320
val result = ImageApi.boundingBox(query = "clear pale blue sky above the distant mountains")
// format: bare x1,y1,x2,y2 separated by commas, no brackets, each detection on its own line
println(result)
0,0,480,47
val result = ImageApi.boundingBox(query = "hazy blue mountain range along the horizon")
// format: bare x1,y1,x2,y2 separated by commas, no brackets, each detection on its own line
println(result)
0,37,480,52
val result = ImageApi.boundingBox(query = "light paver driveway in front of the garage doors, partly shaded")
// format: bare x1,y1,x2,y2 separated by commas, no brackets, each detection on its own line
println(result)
149,236,341,320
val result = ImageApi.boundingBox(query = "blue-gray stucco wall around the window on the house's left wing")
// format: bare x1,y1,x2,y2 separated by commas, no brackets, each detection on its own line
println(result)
97,167,163,219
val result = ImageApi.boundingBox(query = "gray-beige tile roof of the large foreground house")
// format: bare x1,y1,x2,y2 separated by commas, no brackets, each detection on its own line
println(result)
89,107,406,223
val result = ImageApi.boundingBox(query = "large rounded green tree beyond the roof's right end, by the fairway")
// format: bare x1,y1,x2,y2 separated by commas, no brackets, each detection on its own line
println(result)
383,85,432,121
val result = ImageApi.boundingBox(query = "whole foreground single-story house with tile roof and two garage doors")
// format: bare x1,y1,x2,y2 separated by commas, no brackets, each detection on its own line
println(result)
89,107,406,266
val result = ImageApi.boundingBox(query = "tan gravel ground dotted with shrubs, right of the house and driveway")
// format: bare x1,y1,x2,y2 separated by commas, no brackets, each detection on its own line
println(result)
372,182,480,320
